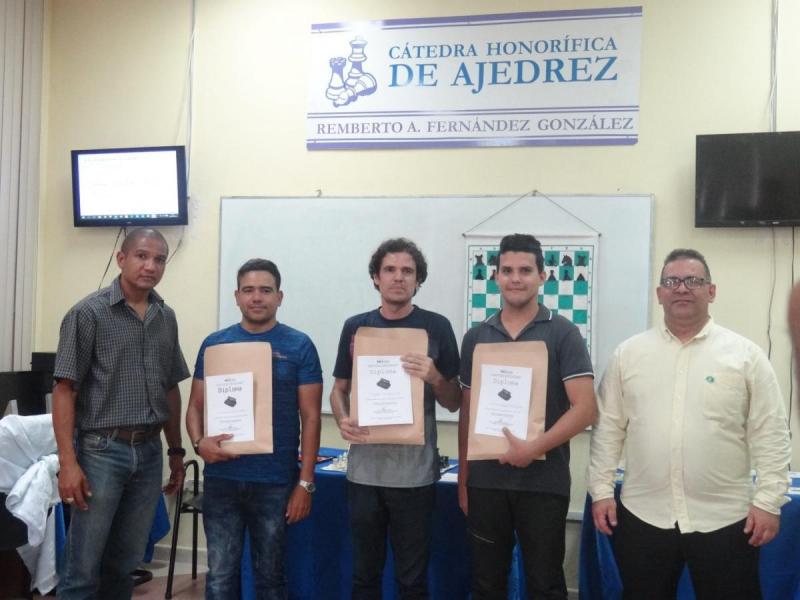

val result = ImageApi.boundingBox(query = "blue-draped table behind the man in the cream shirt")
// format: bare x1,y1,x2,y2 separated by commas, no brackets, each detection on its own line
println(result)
579,476,800,600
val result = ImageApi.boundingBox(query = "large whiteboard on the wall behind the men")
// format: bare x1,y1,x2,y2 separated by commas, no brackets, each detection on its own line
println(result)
218,195,653,420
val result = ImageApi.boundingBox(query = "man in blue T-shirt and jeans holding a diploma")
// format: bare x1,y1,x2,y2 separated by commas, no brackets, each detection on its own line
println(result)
186,258,322,600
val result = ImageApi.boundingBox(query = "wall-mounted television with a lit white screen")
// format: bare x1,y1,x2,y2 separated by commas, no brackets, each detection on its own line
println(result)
72,146,188,227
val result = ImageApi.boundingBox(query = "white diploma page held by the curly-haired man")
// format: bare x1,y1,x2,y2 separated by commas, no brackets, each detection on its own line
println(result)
356,356,414,427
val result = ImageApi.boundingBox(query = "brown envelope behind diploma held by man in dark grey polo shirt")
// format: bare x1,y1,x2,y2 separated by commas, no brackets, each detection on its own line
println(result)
467,342,547,460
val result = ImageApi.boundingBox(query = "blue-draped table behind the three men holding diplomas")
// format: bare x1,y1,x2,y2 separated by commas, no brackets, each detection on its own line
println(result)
242,448,525,600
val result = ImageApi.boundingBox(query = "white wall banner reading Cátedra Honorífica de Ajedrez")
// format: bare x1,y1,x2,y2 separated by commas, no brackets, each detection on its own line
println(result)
306,6,642,150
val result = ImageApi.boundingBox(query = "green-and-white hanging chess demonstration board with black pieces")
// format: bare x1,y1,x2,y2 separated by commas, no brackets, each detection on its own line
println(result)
464,235,598,363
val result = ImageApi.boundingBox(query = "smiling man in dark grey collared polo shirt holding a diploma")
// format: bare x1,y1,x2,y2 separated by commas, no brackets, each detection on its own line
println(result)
458,234,597,600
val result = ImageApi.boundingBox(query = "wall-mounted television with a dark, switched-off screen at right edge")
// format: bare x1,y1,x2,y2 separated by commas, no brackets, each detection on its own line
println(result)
695,131,800,227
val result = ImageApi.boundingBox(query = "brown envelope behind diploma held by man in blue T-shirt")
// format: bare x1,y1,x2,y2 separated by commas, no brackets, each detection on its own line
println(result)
203,342,272,454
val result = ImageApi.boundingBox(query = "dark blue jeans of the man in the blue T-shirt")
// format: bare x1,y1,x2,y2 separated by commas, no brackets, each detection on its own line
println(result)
203,477,295,600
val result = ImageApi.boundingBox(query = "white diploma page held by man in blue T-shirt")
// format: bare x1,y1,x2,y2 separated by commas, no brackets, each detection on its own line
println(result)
206,372,255,442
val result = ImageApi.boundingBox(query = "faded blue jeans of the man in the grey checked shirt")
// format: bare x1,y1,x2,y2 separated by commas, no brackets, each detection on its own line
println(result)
58,433,162,600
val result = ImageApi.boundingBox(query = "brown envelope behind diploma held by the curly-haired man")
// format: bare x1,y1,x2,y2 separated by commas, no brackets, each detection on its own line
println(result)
350,327,428,446
